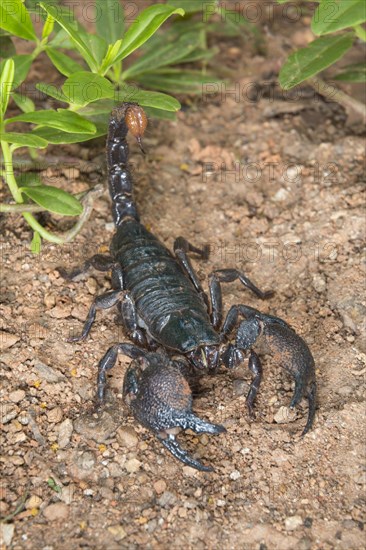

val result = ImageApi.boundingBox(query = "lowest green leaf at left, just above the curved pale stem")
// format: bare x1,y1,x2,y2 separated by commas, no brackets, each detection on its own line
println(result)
19,185,83,216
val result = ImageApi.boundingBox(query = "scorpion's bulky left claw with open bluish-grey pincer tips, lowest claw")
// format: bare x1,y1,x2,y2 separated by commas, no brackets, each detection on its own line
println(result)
123,353,226,472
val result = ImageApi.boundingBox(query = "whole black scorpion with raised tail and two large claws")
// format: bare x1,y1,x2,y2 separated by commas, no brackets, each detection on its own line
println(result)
64,102,316,472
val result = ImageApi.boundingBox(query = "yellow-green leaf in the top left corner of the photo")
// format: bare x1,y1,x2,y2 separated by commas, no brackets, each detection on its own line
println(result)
0,0,37,40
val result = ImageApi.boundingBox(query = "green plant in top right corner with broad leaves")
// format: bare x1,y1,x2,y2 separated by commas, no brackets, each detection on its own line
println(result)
277,0,366,118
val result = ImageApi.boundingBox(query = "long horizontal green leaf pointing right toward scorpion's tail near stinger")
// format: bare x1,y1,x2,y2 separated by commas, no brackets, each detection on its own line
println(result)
5,109,95,134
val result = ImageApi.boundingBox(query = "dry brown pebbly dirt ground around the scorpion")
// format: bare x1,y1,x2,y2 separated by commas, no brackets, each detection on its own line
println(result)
1,2,366,550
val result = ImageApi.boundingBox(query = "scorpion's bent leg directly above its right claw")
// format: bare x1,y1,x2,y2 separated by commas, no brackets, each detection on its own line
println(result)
209,269,273,329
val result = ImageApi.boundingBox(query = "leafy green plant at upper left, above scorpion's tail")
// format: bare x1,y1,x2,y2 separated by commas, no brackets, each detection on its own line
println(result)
0,0,255,251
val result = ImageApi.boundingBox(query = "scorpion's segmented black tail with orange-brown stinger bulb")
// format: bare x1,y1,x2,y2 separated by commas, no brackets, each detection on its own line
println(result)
107,103,147,226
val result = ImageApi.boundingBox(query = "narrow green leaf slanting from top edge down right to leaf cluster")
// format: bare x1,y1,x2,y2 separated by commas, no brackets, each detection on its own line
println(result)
39,2,98,71
